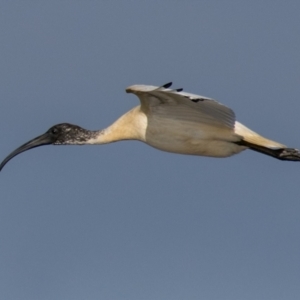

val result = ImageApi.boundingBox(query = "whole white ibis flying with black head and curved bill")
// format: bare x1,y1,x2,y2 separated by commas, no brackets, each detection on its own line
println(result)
0,82,300,171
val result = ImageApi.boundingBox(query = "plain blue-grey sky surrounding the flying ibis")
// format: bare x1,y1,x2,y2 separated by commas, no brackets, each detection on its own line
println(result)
0,0,300,300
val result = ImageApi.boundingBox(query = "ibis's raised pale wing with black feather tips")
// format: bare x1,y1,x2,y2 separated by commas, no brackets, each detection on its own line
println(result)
126,83,235,129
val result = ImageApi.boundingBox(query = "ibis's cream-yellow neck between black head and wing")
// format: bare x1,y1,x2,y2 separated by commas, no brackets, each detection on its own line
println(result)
89,106,147,145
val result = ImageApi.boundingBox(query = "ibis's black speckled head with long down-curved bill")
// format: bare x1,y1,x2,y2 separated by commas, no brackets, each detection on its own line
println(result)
0,123,96,171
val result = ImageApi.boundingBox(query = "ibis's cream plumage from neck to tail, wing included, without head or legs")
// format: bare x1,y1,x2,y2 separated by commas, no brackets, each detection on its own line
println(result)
89,85,285,157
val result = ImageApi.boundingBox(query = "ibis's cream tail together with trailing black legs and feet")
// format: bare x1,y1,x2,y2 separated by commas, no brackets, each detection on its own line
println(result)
235,122,300,161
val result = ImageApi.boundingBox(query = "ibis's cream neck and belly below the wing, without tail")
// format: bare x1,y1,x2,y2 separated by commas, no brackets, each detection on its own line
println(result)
93,98,246,157
